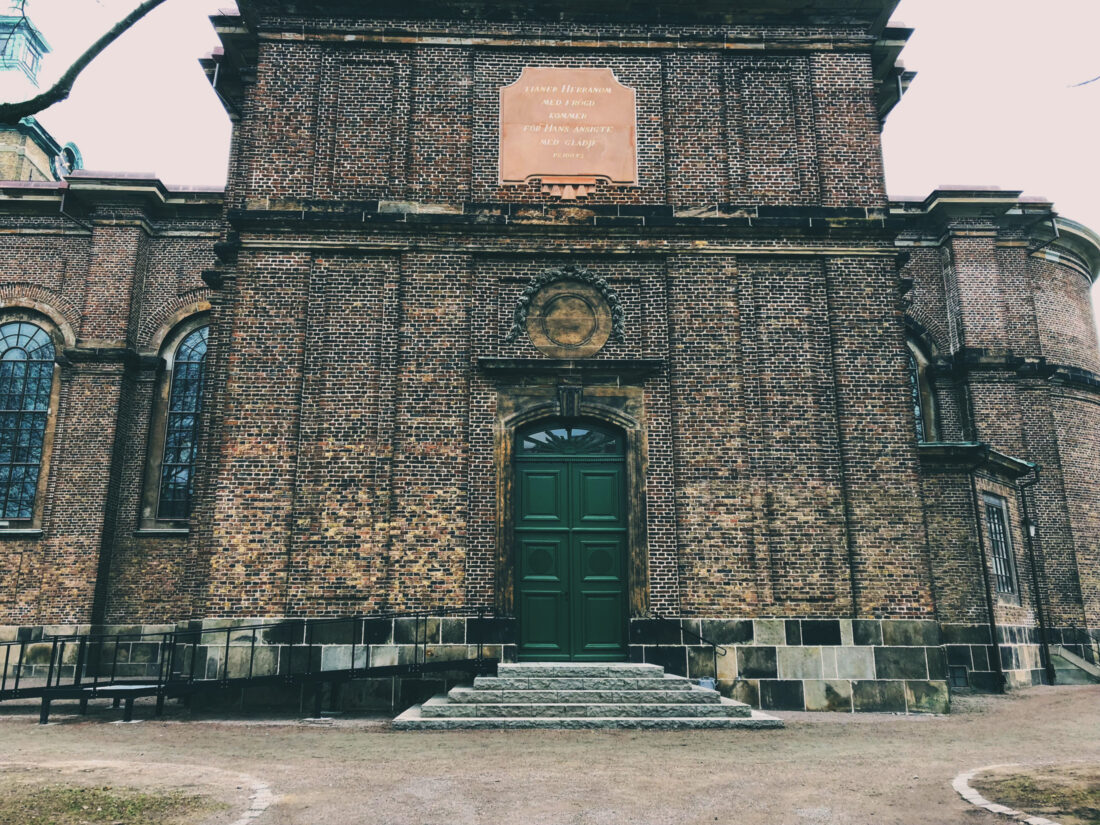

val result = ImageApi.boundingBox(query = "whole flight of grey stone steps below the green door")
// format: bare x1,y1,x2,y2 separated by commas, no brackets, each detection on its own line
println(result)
394,662,783,730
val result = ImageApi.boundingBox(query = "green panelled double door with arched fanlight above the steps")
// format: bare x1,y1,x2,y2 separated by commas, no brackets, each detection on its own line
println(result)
515,421,628,661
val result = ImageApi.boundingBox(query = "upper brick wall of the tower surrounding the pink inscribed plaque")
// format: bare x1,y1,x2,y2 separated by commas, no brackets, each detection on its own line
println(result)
230,18,884,208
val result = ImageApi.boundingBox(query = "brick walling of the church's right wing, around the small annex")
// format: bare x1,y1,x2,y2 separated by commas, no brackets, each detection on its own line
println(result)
905,210,1100,642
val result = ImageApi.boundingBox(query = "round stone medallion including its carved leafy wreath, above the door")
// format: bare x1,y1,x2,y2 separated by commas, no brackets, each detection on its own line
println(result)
507,265,623,359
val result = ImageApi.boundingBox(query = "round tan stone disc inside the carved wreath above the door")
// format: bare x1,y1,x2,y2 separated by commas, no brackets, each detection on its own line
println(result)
527,281,612,359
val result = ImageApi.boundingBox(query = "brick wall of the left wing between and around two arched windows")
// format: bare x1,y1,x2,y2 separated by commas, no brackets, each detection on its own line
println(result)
0,180,219,625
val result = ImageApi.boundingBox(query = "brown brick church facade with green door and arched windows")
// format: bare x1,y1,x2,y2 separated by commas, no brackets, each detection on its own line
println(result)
0,0,1100,712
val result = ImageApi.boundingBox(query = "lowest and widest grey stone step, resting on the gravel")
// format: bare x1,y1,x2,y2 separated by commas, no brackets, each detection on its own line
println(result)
393,705,783,730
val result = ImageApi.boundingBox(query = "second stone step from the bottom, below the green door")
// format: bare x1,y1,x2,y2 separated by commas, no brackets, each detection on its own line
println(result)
420,694,752,718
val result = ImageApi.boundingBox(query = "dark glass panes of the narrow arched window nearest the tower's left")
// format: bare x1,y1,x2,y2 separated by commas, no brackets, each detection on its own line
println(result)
156,327,210,521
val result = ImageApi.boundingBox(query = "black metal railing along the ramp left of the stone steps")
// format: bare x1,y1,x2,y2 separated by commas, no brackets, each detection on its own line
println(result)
0,608,508,722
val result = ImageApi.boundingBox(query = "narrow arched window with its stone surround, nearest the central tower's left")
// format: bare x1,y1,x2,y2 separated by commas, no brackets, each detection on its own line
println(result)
141,318,210,530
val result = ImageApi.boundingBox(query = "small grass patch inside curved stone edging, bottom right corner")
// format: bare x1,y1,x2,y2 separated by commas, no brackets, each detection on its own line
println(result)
970,766,1100,825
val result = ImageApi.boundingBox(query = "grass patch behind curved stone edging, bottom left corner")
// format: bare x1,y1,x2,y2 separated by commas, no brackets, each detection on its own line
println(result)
0,785,224,825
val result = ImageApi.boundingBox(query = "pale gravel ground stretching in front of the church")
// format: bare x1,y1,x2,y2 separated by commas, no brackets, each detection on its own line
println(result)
0,685,1100,825
